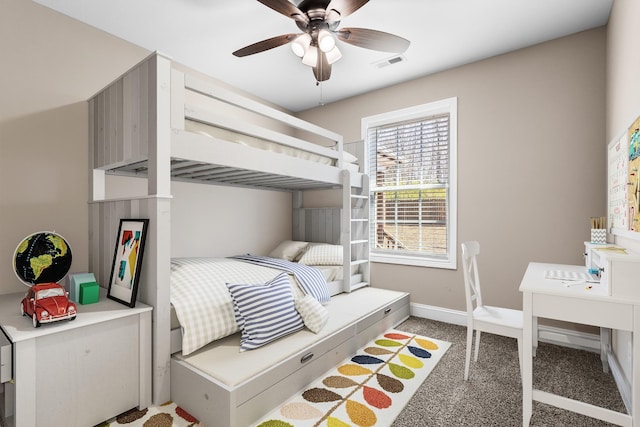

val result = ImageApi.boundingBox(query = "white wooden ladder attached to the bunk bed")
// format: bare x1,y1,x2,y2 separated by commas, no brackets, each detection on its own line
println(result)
341,170,369,292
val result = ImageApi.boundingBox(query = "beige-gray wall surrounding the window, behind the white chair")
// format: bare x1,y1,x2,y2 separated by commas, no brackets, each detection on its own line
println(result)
301,28,606,316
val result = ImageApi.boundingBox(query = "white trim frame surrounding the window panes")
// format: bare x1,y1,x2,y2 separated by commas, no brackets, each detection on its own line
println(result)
361,97,458,270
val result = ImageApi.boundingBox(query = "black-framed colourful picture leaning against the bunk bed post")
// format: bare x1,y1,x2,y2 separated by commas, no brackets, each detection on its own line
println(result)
107,219,149,307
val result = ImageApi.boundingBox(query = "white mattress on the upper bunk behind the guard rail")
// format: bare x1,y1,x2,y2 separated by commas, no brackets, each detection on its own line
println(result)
185,120,359,172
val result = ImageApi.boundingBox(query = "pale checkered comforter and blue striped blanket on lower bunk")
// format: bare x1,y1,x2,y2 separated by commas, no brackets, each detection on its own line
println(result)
170,255,330,355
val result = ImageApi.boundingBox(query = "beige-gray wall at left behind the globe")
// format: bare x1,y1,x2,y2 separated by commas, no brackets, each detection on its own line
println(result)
0,0,148,294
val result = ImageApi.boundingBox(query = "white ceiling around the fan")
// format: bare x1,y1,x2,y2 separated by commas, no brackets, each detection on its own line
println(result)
34,0,613,111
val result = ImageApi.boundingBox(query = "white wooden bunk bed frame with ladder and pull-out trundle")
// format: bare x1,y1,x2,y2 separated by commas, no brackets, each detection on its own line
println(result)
89,53,409,425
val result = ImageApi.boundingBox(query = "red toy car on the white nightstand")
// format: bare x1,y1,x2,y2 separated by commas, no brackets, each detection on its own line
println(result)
20,283,76,328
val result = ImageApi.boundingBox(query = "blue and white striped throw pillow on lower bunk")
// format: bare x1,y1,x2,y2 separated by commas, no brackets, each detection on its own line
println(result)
227,273,304,351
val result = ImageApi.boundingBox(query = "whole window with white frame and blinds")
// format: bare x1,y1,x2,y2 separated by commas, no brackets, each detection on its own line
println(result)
362,98,457,269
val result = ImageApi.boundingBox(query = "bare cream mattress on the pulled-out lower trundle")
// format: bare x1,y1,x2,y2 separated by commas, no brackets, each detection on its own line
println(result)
173,287,406,387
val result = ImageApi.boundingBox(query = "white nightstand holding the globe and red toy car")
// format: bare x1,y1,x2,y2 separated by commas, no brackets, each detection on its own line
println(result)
0,288,151,427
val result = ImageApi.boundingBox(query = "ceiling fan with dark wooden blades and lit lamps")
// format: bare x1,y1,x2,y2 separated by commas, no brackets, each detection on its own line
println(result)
233,0,411,82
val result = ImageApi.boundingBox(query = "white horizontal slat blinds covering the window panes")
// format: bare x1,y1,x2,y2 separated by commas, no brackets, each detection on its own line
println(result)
367,112,451,259
